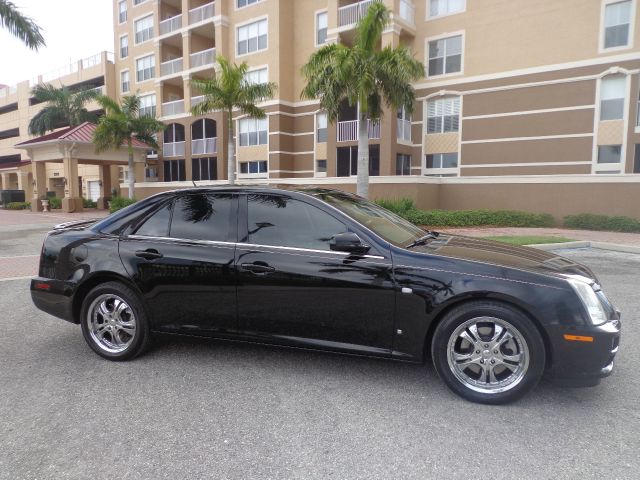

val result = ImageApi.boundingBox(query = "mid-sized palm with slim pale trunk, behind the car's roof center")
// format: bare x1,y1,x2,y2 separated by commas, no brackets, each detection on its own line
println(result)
191,56,277,185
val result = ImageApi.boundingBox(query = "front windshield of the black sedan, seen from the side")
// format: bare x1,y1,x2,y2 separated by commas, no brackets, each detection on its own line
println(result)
318,192,425,247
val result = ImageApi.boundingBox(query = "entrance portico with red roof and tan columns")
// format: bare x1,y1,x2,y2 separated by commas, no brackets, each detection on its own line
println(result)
16,122,149,212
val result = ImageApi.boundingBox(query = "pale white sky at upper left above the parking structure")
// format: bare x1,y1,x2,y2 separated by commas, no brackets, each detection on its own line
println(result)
0,0,113,85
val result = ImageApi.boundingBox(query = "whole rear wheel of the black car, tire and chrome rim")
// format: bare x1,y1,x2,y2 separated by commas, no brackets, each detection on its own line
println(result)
80,282,151,361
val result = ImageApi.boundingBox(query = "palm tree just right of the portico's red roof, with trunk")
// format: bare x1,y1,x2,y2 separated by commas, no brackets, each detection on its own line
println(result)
93,94,165,198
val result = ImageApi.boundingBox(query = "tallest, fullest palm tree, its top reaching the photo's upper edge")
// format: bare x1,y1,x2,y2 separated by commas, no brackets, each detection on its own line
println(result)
302,1,424,198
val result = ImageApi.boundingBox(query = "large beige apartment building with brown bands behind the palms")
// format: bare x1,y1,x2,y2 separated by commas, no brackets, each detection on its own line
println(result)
0,0,640,218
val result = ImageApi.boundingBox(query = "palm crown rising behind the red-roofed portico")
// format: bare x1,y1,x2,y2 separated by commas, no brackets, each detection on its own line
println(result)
29,84,100,135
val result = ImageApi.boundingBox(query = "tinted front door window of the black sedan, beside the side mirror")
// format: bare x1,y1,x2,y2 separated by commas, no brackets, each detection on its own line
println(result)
248,195,346,250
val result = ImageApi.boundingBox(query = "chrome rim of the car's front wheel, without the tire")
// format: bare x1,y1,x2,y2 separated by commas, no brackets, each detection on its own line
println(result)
447,317,529,394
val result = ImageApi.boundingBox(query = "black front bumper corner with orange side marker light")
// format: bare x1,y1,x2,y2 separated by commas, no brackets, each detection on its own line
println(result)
548,314,621,386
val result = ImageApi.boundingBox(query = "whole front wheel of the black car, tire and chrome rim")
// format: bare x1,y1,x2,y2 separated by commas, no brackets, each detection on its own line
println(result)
431,300,545,405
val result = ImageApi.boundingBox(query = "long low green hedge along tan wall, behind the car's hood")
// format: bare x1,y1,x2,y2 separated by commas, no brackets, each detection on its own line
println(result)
377,198,554,227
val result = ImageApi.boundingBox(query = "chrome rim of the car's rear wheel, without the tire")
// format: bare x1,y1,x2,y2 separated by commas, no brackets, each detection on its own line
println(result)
86,294,136,353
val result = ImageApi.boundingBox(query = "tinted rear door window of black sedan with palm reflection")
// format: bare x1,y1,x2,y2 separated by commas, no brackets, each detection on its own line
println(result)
170,193,235,242
